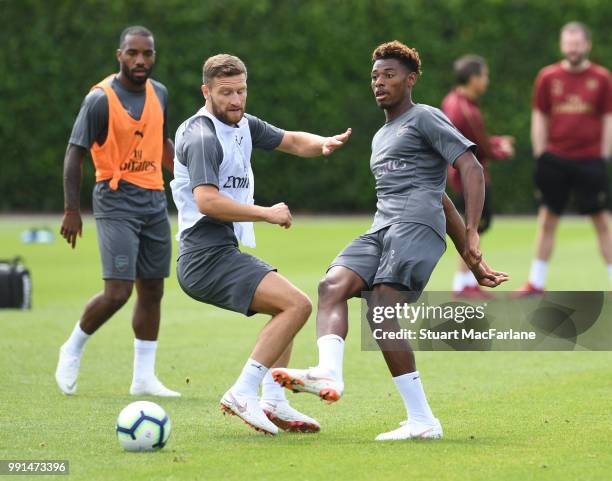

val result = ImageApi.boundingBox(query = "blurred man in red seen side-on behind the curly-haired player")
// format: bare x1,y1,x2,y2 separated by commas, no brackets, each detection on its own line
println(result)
442,55,514,299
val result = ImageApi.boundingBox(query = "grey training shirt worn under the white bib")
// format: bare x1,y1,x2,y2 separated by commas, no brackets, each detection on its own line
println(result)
175,114,285,257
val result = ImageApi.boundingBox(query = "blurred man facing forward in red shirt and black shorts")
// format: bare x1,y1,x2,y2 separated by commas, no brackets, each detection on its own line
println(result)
515,22,612,296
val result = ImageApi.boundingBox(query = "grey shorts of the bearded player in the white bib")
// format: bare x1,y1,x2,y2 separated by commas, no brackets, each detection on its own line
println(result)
176,245,276,316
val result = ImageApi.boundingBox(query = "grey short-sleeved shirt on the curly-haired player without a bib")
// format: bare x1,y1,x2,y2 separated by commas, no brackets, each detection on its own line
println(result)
368,104,476,239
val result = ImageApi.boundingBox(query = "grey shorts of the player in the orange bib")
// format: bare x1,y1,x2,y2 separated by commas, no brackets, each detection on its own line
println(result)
96,210,172,281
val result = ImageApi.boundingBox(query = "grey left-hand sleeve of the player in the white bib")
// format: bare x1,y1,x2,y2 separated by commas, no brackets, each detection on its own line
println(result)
182,118,223,190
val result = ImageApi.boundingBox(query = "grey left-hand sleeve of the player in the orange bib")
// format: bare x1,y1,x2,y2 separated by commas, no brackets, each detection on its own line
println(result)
68,88,108,149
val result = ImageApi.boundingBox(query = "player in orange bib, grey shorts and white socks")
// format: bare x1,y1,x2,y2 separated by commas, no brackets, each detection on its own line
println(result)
55,26,180,397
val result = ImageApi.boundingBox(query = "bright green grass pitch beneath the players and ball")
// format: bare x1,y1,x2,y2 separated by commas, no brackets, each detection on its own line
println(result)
0,216,612,481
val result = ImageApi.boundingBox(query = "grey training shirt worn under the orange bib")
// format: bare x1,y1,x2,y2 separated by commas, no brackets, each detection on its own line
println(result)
68,78,168,218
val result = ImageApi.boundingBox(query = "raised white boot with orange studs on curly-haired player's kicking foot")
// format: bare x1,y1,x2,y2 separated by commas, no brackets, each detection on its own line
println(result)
272,367,344,403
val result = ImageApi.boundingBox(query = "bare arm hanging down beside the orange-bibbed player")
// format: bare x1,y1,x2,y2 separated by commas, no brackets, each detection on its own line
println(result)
60,144,87,249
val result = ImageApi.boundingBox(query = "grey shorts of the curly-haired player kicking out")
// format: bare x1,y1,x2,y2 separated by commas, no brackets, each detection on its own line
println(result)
328,222,446,293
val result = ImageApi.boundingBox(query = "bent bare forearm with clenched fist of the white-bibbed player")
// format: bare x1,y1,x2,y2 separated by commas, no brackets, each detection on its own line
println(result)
193,184,293,229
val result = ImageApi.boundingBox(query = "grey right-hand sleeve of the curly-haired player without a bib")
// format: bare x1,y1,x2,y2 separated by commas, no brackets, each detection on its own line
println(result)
416,109,476,165
